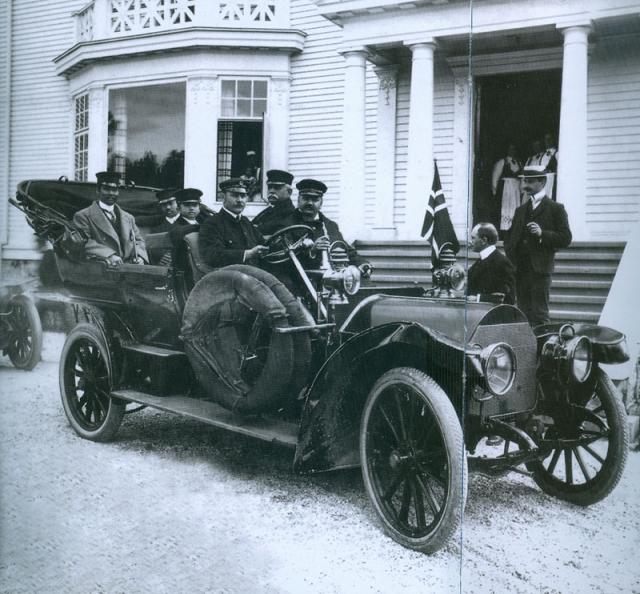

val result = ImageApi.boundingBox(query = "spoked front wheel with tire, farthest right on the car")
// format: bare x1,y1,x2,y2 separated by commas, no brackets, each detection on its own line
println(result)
528,369,629,505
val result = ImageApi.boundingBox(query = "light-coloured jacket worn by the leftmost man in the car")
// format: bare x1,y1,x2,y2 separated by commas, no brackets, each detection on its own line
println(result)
73,202,149,262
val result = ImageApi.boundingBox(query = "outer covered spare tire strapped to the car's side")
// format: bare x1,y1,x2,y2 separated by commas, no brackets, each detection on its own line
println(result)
182,268,294,413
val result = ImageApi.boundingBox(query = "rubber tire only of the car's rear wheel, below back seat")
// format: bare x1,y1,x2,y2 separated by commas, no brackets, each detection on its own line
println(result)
58,323,126,442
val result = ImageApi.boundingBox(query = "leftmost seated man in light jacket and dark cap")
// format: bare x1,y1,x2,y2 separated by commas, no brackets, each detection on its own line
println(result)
73,171,149,266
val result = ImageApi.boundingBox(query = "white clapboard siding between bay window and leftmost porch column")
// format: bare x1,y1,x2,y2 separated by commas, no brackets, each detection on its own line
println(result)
289,0,344,217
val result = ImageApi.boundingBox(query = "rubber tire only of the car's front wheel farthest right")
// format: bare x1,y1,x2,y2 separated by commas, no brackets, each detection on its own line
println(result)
527,368,629,506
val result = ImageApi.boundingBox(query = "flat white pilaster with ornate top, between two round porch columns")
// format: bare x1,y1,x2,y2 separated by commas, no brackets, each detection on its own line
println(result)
373,66,398,239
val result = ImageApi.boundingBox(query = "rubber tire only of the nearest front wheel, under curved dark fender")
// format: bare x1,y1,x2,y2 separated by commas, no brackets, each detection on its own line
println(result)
360,367,467,553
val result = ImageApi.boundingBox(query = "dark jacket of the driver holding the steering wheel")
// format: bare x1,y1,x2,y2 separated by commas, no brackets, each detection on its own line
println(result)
199,209,265,268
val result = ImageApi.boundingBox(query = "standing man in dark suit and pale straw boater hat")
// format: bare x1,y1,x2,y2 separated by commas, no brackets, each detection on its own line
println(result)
505,166,571,326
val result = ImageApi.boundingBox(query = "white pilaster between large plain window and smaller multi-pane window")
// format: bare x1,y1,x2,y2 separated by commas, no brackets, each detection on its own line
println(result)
184,75,220,206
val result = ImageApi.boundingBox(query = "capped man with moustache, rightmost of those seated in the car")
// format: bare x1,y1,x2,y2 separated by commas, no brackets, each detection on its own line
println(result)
279,179,373,278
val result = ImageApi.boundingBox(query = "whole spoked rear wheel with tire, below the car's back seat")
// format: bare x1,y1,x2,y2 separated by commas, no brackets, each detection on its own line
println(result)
60,324,126,441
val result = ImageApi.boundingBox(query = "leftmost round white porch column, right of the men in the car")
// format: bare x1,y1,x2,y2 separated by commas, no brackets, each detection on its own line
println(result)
339,50,367,241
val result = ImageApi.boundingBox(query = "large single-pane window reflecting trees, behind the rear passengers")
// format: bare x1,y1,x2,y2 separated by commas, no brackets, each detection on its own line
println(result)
107,83,186,188
